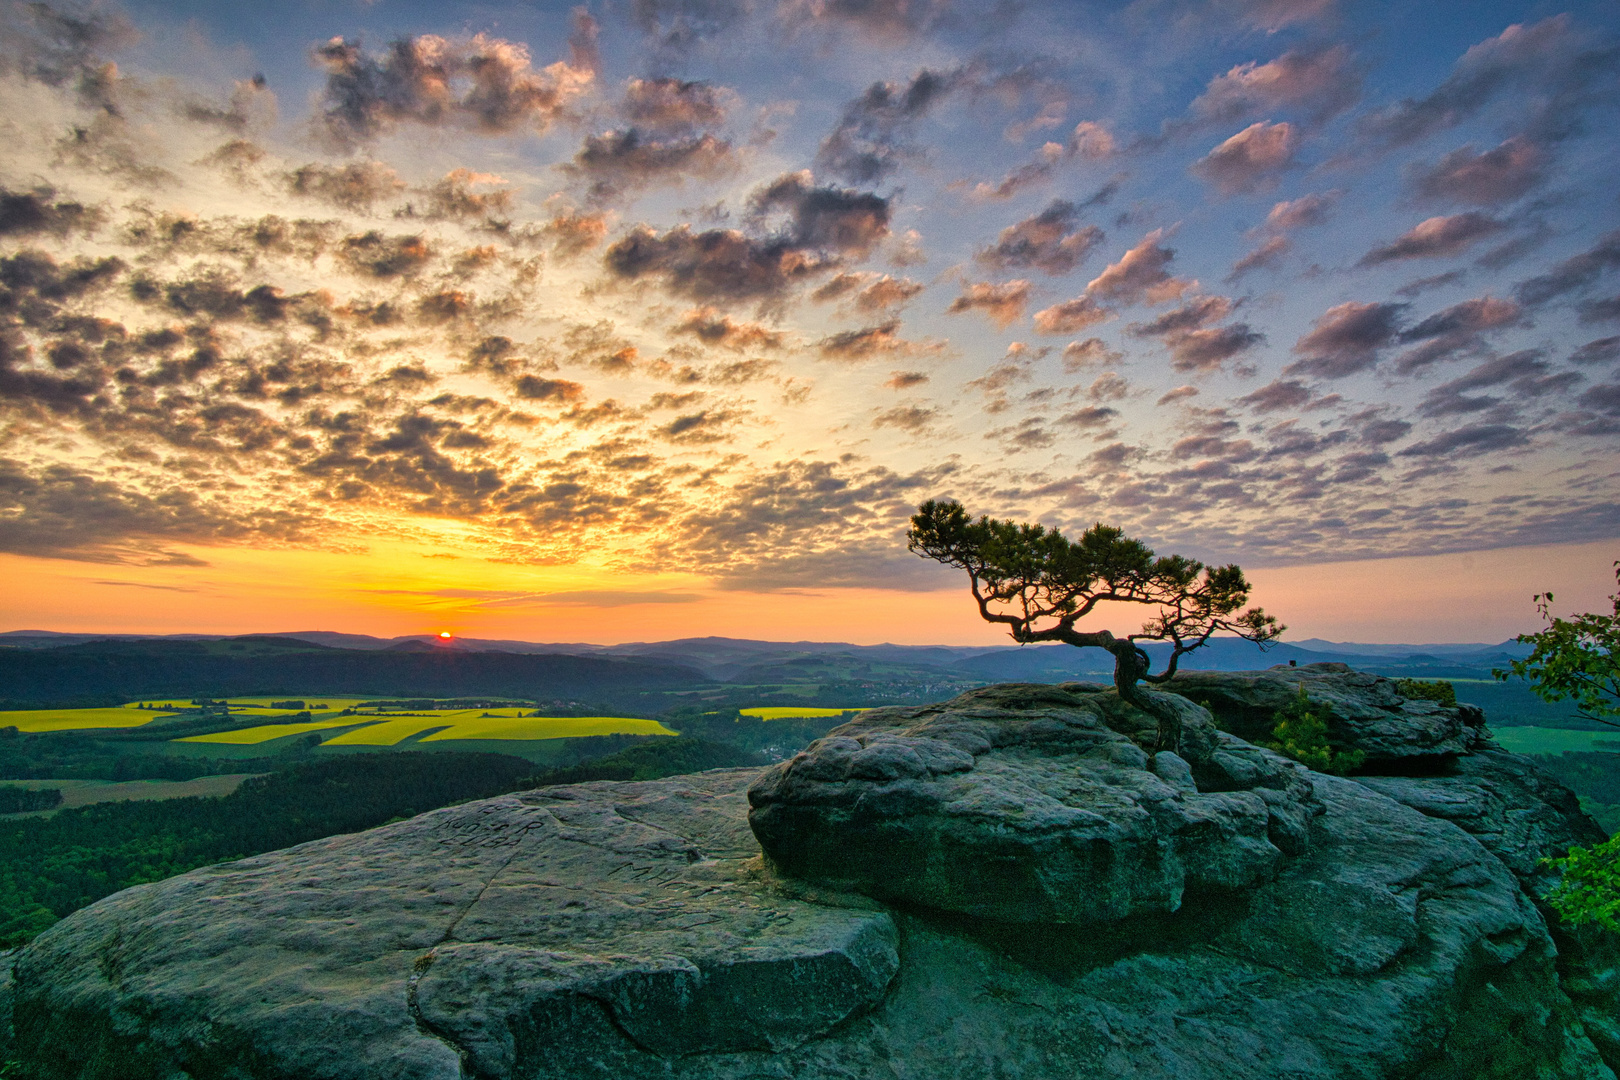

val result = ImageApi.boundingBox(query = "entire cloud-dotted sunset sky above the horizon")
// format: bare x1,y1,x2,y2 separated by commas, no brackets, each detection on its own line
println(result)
0,0,1620,644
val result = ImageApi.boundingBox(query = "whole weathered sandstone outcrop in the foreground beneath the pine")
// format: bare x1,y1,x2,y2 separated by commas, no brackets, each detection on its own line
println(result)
0,665,1620,1080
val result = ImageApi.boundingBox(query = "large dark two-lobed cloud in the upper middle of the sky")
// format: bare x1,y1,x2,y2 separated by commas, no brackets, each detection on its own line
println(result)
604,173,889,300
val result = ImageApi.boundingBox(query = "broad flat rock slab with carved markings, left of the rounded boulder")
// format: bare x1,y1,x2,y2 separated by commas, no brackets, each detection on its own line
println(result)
16,769,897,1078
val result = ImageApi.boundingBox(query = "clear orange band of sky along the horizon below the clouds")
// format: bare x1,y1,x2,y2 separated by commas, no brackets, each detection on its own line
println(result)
0,542,1620,644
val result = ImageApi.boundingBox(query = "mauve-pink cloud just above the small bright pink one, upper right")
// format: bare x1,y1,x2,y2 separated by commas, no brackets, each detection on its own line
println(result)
1189,45,1361,125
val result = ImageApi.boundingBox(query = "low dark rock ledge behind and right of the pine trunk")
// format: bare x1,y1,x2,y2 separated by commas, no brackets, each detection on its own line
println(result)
1163,664,1487,771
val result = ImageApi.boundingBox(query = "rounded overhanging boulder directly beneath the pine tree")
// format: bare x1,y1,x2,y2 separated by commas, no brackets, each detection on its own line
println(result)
748,683,1312,923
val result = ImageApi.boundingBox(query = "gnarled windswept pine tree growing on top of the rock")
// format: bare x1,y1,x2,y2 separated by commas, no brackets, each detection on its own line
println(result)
906,499,1286,735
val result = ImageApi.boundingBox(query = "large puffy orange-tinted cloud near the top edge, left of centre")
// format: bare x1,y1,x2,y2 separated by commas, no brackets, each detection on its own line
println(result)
314,23,596,146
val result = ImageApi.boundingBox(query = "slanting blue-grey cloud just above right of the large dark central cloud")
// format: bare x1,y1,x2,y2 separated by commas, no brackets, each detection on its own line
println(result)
815,66,961,183
